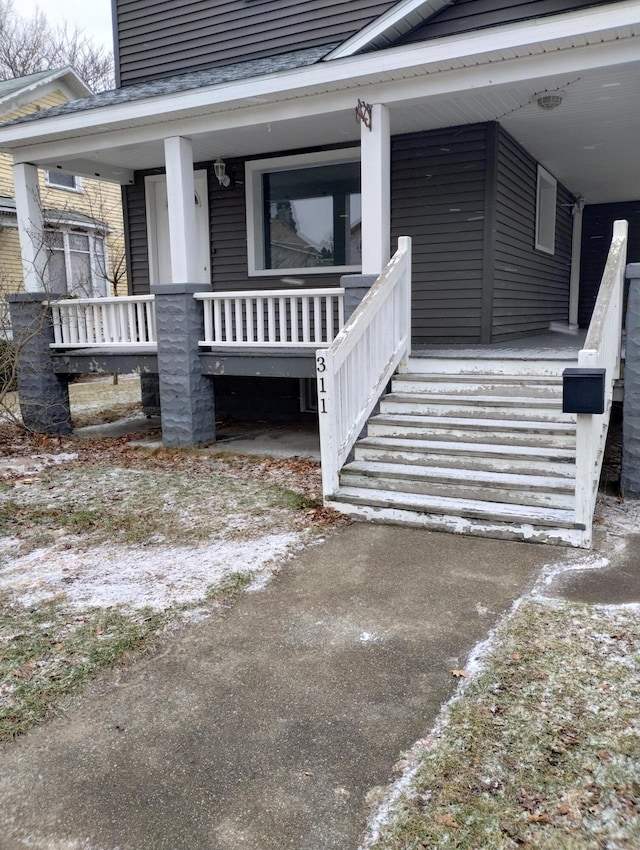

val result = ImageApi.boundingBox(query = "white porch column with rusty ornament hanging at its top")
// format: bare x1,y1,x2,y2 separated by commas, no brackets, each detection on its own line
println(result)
360,103,391,275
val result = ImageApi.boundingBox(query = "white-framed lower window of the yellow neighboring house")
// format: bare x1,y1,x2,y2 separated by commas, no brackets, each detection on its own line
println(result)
47,230,108,298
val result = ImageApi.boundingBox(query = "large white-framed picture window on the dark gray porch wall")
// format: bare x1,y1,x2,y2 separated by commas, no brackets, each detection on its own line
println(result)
246,149,362,275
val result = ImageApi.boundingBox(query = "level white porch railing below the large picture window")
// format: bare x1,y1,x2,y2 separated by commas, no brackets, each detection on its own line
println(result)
194,287,344,348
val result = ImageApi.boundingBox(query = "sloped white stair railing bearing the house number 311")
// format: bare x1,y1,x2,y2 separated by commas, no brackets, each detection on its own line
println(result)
316,236,411,498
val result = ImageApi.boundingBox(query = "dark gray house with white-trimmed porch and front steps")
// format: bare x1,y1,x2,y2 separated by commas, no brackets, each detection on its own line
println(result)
0,0,640,546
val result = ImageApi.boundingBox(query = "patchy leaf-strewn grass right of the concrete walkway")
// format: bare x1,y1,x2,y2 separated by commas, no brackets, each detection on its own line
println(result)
370,602,640,850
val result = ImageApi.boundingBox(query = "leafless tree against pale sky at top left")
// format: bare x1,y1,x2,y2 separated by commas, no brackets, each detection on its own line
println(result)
0,0,114,91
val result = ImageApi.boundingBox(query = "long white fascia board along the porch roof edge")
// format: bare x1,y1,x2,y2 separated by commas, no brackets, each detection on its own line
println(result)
0,0,640,150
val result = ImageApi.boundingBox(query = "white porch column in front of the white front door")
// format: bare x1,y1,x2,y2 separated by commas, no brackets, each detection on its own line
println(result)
164,136,199,283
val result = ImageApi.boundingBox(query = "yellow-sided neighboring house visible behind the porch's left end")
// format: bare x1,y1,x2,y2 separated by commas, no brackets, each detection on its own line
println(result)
0,68,127,297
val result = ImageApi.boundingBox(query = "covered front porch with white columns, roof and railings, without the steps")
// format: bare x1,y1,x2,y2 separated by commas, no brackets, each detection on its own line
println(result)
0,0,640,545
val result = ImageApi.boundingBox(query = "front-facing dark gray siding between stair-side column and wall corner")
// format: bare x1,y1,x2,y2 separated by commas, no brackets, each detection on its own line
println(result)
391,125,487,346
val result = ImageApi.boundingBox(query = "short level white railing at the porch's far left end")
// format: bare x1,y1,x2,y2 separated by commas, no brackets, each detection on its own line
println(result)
51,295,156,348
